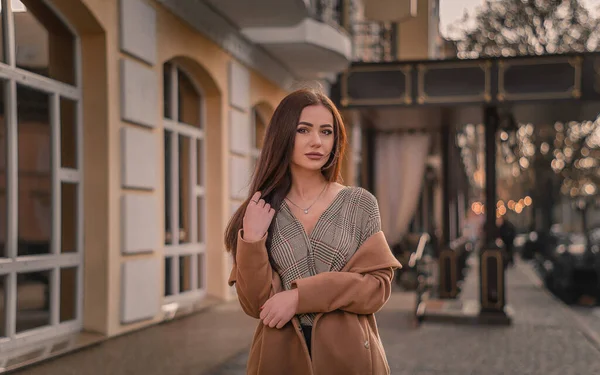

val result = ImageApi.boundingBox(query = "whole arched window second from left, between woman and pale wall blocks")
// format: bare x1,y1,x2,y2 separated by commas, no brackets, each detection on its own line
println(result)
163,62,206,299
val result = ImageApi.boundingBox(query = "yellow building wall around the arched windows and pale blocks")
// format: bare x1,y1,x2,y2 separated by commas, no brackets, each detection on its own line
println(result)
47,0,285,336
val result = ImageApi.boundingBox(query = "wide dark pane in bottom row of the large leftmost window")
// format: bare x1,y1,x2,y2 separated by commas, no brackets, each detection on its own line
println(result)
16,271,51,333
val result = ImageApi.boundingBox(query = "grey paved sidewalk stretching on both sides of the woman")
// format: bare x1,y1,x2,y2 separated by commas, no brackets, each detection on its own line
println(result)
16,262,600,375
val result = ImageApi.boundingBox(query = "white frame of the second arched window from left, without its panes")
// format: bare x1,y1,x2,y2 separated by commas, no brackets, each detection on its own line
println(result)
163,61,208,304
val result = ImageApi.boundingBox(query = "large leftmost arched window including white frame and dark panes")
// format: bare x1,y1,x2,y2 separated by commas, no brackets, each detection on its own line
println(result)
0,0,83,352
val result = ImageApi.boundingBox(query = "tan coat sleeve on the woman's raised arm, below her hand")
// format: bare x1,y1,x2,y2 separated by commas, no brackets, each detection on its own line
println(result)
229,230,274,319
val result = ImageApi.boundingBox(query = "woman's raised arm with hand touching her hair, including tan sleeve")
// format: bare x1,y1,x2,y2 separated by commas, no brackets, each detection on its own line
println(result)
229,192,275,319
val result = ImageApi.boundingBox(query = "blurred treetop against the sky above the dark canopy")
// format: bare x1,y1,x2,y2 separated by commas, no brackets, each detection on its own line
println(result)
450,0,600,58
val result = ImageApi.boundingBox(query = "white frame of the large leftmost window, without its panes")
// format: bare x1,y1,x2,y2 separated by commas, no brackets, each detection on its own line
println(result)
0,0,84,353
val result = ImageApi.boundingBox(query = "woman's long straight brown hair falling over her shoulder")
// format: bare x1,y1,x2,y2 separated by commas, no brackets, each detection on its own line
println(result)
225,89,346,261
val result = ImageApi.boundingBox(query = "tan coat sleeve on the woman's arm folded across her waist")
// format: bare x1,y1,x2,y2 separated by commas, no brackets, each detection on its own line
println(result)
292,267,394,314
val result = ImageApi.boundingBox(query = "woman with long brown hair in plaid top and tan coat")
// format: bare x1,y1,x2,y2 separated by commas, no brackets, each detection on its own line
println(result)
225,90,400,375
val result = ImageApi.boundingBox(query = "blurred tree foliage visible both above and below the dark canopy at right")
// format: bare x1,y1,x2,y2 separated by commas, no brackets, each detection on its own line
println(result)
449,0,600,238
